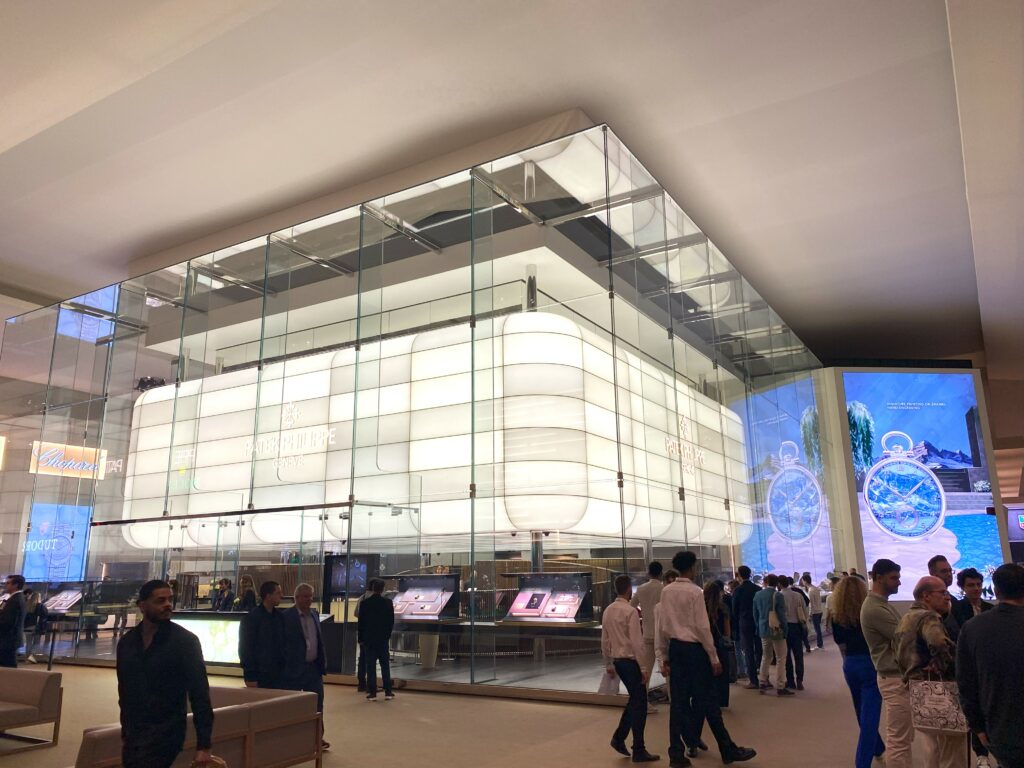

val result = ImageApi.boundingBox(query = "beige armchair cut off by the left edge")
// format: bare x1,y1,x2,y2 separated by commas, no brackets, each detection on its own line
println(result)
0,667,63,755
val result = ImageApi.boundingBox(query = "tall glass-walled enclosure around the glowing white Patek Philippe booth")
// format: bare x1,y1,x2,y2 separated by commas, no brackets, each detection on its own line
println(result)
0,126,837,691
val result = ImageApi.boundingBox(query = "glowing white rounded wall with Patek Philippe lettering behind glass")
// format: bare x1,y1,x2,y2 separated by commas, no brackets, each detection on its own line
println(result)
124,312,751,547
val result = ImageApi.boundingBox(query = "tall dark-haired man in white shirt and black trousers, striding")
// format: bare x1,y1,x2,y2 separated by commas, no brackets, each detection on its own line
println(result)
655,552,757,768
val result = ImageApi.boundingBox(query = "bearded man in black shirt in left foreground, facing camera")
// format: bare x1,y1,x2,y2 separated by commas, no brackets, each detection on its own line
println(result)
118,581,213,768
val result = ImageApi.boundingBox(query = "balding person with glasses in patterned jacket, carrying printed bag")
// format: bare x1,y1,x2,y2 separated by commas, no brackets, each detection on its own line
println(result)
893,577,971,768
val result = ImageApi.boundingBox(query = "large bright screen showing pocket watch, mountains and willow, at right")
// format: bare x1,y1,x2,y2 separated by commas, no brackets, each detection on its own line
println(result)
843,371,1002,600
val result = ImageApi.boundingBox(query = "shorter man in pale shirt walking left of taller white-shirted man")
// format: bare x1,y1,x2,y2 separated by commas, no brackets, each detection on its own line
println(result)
601,574,659,763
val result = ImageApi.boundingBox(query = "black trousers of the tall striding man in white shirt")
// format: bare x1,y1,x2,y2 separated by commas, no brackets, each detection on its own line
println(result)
669,640,736,762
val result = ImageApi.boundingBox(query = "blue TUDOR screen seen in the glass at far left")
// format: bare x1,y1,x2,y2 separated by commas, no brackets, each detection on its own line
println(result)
22,504,92,582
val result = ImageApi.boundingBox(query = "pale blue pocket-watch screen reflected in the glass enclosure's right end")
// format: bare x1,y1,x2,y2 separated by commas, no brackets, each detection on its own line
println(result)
740,376,837,582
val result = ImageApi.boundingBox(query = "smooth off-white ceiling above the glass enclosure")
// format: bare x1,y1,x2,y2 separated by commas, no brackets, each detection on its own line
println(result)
0,0,1024,372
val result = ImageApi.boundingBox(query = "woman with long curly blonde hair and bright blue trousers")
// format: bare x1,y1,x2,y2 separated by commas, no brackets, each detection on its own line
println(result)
831,577,886,768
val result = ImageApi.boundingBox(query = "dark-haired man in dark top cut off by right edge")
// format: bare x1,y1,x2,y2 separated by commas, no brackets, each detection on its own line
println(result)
956,563,1024,768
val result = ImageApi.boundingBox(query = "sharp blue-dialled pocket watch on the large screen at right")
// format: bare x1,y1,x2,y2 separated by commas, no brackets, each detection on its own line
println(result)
863,431,946,539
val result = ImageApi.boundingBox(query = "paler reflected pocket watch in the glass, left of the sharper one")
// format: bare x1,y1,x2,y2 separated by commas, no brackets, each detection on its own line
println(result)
768,440,824,544
